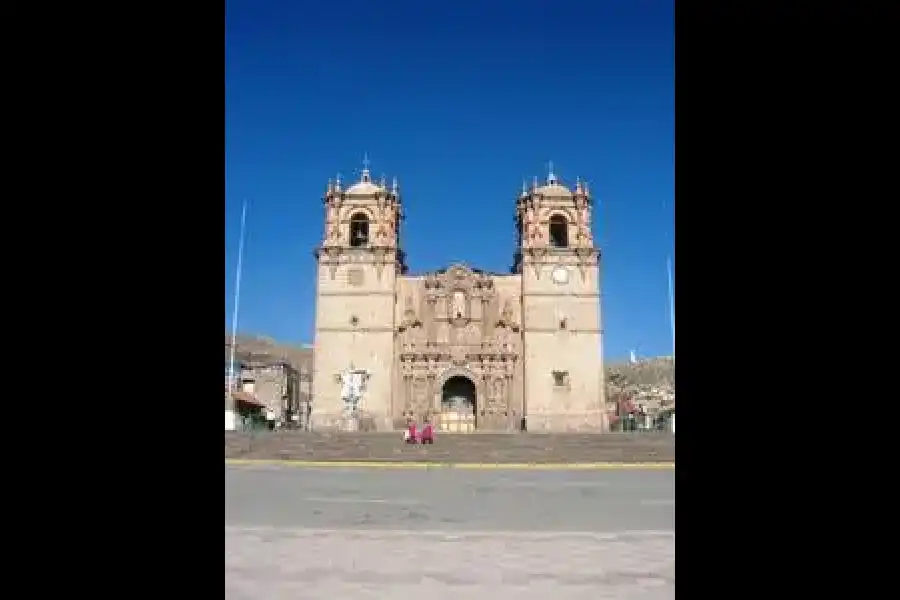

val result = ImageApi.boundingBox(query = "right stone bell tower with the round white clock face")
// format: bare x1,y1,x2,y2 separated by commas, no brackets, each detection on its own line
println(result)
513,163,608,432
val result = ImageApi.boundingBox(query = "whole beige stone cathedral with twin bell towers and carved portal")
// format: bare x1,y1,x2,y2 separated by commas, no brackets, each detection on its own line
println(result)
311,162,608,432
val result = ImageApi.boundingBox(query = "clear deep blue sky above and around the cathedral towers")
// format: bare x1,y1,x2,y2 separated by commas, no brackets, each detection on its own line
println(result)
225,0,675,359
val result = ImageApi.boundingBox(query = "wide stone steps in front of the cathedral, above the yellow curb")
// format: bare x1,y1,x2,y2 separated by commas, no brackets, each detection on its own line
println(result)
225,431,675,464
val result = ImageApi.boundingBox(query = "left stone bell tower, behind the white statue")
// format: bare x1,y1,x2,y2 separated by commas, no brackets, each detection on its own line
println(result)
311,158,406,430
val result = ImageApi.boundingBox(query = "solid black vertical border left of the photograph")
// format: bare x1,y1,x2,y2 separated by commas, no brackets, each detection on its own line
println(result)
11,3,225,598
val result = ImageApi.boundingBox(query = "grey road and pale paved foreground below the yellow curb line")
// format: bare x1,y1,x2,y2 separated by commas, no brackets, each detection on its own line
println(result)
225,466,675,600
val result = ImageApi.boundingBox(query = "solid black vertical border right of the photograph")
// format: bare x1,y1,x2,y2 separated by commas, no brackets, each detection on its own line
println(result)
675,2,880,597
